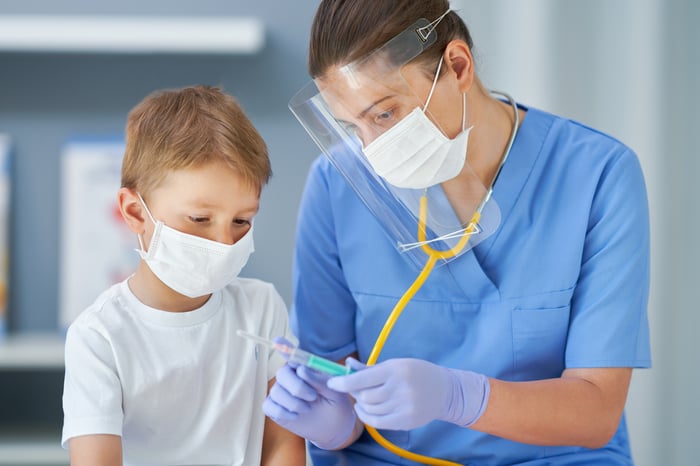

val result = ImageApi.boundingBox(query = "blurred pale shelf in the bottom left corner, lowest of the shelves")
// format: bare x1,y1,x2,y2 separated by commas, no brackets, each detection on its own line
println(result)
0,428,69,466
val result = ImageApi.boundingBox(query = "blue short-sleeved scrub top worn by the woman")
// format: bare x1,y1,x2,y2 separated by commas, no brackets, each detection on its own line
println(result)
291,108,651,466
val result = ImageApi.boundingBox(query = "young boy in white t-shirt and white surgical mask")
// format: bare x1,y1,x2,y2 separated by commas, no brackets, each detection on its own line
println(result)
62,86,305,466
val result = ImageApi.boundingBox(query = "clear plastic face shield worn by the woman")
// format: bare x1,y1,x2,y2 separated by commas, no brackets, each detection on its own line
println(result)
289,18,501,267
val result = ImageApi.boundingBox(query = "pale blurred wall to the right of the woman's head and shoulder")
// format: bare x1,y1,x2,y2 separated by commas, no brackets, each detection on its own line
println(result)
451,0,700,466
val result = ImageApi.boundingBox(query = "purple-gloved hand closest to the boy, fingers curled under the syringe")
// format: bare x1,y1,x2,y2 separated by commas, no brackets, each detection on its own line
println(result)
263,340,357,450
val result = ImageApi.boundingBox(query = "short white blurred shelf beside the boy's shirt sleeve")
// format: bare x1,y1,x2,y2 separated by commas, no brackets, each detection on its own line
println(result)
0,333,65,370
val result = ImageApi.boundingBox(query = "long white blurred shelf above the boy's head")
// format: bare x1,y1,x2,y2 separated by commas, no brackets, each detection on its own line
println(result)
0,15,265,54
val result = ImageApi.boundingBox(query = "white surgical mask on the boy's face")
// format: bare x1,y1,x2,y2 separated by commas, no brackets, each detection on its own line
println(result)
137,194,255,298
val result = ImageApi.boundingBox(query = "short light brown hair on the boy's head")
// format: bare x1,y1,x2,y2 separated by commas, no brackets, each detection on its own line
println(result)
122,86,272,197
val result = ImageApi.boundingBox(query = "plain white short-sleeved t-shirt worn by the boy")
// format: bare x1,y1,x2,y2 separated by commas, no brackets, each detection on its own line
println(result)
61,278,291,466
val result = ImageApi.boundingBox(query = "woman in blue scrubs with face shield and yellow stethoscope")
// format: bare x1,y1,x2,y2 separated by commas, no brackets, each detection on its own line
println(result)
264,0,650,466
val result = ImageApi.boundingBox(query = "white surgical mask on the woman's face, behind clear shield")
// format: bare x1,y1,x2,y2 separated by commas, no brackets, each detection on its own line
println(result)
362,57,472,189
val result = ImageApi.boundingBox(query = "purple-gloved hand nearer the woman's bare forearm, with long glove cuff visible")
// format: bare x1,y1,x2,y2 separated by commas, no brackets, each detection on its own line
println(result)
328,358,490,430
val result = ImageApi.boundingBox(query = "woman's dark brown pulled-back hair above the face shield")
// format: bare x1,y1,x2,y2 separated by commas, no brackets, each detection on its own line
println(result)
309,0,473,78
